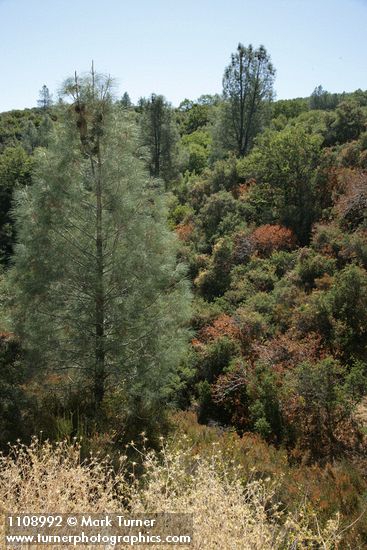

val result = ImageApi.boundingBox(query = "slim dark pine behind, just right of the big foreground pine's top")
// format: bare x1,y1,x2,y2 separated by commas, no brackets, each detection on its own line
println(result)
140,94,178,188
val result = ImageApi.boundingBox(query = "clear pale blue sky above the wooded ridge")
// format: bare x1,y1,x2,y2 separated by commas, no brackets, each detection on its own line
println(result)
0,0,367,111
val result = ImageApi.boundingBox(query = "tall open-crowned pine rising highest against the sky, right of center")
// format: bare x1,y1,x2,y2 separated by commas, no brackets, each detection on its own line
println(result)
223,44,275,156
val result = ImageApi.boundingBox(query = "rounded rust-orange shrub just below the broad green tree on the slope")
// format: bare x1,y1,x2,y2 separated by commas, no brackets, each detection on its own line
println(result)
250,224,296,256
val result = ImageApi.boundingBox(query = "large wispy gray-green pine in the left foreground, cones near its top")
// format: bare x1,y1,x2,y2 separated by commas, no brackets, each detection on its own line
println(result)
12,73,189,420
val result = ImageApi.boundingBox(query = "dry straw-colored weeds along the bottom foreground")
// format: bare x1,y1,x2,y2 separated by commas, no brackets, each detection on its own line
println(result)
0,440,339,550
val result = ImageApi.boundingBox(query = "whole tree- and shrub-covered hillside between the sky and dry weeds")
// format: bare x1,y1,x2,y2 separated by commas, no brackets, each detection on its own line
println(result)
0,44,367,548
